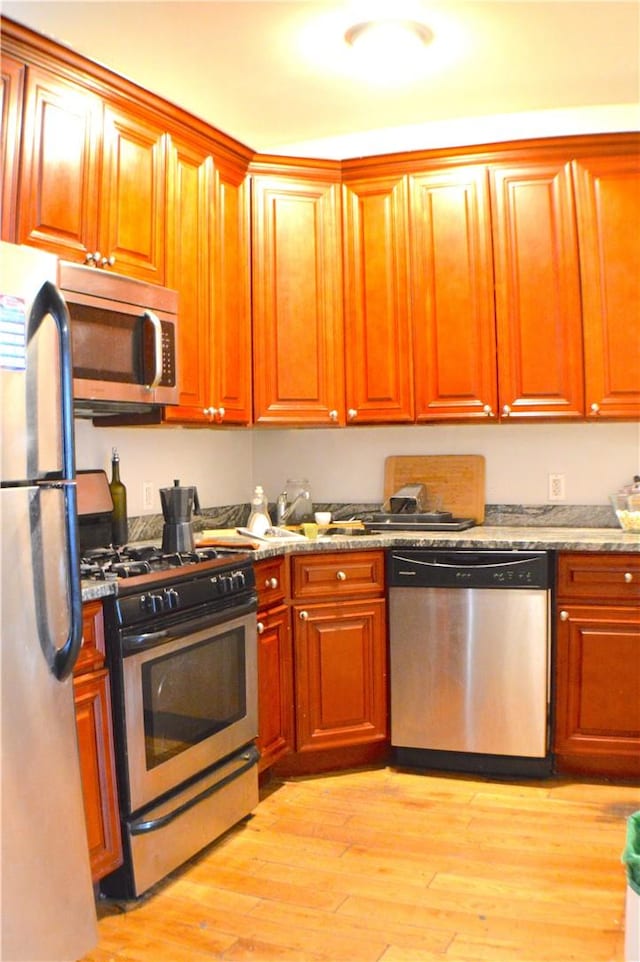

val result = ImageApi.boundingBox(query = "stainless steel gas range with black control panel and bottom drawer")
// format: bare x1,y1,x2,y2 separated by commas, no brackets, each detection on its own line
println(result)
82,545,259,899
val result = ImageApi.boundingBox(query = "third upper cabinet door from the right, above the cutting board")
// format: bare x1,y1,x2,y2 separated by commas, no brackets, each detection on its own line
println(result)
409,167,497,421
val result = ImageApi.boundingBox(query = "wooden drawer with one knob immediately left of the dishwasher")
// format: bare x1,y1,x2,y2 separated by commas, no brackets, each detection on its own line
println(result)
291,551,384,600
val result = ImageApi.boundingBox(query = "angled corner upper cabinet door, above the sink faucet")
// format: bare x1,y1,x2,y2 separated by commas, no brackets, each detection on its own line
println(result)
252,175,344,425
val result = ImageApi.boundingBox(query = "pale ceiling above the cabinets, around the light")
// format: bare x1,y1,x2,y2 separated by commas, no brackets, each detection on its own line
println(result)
2,0,640,159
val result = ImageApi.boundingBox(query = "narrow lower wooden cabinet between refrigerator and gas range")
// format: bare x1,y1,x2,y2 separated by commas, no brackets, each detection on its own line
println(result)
73,602,122,882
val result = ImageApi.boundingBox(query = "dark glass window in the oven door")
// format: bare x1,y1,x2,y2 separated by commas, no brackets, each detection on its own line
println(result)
142,627,247,769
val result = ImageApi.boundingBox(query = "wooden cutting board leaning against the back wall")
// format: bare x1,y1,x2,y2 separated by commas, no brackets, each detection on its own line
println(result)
384,454,485,524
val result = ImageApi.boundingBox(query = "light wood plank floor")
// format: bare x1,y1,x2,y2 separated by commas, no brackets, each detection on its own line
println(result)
86,768,640,962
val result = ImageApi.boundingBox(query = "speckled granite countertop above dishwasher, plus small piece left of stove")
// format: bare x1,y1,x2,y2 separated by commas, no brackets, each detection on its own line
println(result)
82,525,640,601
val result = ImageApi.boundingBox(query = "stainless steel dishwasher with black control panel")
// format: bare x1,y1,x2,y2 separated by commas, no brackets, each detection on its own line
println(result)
388,548,552,775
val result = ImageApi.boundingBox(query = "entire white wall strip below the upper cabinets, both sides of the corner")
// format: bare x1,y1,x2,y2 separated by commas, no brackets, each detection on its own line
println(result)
75,421,640,516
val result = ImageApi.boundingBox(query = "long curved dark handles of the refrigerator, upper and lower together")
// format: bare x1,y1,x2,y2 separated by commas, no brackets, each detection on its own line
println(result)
27,281,82,681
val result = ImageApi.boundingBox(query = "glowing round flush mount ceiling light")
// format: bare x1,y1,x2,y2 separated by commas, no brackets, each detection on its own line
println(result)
344,19,433,77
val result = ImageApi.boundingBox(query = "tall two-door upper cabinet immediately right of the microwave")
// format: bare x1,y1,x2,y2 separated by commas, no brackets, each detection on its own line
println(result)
164,136,251,424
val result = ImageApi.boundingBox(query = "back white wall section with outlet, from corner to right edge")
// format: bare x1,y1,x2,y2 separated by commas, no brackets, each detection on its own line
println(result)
254,422,640,504
